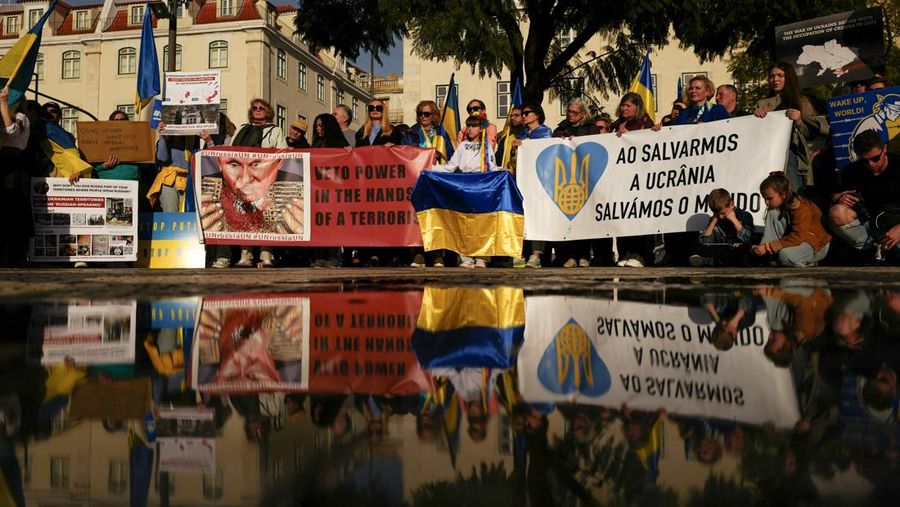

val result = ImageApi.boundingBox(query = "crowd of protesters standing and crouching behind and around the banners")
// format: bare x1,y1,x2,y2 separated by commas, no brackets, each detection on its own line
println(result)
0,63,900,268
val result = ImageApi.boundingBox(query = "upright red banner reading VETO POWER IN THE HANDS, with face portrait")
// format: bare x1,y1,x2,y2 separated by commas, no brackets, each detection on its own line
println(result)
194,146,434,246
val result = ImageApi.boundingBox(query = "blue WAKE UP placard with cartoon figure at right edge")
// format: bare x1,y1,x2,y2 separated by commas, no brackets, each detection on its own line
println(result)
828,86,900,169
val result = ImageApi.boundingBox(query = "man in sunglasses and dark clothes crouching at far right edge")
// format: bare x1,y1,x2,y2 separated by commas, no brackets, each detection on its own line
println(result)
828,130,900,261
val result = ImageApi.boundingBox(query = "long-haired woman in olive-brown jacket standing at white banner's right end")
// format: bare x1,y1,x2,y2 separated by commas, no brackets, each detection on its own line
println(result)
753,62,829,190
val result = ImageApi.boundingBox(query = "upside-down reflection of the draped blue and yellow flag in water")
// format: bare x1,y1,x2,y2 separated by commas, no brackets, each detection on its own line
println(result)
412,287,525,369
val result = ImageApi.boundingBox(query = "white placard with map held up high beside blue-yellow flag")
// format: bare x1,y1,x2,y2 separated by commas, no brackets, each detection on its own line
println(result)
162,70,221,135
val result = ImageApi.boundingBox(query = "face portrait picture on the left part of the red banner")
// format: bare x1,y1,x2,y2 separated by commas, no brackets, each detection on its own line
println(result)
194,148,310,245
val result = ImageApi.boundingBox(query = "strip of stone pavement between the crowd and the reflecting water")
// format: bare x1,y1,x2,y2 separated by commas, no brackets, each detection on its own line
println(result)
0,267,900,302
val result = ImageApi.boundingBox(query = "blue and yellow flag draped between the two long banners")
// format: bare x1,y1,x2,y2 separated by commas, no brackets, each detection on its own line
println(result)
410,171,525,257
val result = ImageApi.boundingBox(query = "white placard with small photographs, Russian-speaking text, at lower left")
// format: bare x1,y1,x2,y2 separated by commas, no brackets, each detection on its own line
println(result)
31,178,138,262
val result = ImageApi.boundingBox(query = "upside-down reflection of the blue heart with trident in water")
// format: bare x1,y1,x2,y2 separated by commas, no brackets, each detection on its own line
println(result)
538,319,612,397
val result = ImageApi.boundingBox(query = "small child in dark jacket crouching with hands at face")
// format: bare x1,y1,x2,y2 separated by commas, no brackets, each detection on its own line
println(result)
688,188,753,267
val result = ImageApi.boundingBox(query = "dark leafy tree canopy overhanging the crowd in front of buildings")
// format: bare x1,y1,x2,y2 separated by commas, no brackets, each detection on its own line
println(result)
296,0,865,102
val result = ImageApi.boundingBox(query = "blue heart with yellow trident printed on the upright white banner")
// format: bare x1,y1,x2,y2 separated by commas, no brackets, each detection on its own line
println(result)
535,143,609,220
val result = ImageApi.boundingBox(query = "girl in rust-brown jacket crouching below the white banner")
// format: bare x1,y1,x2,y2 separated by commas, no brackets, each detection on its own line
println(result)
752,171,831,268
